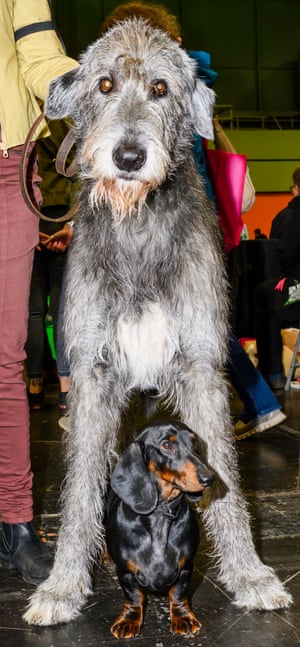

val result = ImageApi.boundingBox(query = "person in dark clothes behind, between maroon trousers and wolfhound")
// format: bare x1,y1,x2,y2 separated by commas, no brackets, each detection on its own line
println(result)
25,120,72,410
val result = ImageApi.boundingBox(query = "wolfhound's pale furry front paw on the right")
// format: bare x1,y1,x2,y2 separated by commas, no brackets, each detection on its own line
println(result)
234,569,293,611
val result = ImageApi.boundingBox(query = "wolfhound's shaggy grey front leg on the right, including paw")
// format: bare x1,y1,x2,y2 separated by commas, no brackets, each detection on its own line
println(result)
175,372,292,610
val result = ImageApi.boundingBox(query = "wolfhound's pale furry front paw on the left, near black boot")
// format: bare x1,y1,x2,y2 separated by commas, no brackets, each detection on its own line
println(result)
23,585,85,626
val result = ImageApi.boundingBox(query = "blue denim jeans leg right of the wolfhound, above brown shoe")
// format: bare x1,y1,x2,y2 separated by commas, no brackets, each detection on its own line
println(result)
228,332,282,422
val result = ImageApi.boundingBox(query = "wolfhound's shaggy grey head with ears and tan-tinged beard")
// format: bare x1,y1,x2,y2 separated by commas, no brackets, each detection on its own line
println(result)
45,18,214,219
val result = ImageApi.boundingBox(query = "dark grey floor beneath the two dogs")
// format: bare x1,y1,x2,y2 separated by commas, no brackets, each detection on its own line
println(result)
0,386,300,647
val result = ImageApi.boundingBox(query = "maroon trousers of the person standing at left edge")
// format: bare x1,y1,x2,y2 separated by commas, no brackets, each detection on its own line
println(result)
0,147,39,523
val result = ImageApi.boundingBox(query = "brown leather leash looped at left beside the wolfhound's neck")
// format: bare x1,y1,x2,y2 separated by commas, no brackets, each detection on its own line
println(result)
20,114,77,222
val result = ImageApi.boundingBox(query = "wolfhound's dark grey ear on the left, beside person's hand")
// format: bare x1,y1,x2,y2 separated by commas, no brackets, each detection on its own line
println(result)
45,67,82,119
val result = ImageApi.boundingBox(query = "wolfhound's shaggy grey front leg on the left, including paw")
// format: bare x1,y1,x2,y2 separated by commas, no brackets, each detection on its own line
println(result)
24,378,123,625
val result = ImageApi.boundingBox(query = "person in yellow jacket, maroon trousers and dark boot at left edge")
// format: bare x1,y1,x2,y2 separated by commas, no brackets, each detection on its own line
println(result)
0,0,78,584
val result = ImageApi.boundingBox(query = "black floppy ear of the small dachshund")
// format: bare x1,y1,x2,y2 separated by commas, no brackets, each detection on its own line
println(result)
111,443,158,514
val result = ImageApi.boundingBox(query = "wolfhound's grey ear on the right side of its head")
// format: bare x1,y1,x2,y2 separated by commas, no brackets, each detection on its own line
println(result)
192,79,215,139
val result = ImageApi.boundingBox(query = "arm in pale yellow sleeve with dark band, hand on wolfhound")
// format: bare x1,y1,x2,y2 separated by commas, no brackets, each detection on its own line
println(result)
14,0,78,99
